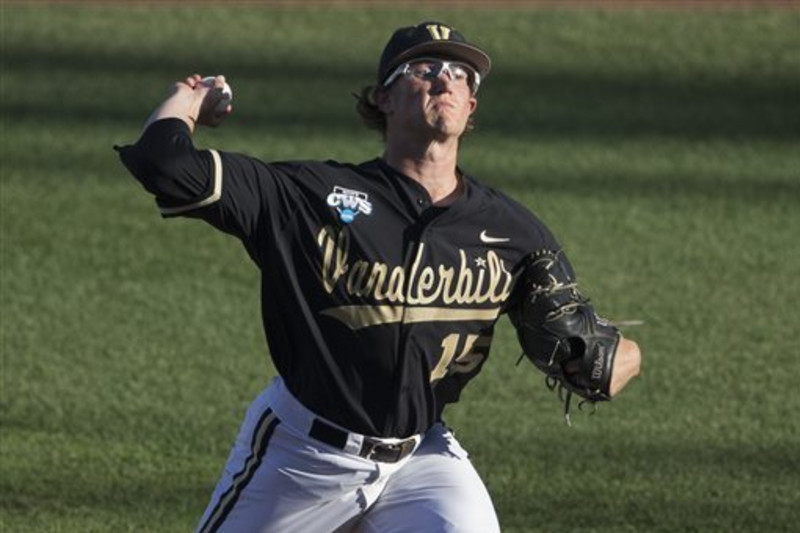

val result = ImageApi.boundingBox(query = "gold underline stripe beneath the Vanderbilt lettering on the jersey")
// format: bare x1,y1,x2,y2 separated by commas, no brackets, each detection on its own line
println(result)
322,305,500,330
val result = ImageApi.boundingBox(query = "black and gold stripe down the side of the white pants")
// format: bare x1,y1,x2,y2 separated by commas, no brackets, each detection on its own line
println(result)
199,409,281,533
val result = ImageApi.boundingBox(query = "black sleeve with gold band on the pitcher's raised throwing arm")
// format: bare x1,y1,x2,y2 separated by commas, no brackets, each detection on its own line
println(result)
117,119,304,262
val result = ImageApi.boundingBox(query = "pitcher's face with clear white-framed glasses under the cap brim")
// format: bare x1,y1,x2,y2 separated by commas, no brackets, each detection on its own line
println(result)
380,59,478,140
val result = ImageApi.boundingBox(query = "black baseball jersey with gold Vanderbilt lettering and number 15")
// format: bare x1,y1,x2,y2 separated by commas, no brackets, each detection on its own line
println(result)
119,119,558,437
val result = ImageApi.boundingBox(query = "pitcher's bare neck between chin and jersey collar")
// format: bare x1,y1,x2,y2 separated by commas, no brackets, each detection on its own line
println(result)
383,139,461,205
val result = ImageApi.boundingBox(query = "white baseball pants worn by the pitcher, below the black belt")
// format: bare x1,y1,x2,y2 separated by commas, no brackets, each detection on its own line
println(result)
197,378,500,533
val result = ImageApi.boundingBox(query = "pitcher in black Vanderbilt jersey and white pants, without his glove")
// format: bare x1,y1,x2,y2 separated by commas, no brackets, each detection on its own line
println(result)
117,18,639,533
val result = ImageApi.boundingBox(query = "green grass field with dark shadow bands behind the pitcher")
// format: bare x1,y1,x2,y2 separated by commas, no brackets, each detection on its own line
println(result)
0,6,800,532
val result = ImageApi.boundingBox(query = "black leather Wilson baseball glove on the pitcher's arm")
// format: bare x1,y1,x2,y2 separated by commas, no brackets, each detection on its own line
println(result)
509,250,620,425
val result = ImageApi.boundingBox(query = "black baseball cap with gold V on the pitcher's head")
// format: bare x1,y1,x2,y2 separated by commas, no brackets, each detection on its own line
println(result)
378,21,492,84
